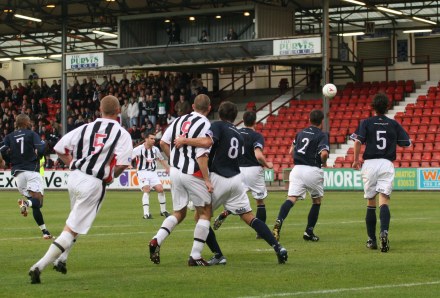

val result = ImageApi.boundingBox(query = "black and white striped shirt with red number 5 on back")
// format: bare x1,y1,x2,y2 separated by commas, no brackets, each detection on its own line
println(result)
54,118,133,182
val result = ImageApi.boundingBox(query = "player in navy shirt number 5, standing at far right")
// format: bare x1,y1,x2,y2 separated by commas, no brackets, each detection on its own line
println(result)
351,94,411,252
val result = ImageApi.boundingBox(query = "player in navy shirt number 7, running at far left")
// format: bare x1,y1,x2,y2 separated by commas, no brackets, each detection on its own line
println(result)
0,114,52,239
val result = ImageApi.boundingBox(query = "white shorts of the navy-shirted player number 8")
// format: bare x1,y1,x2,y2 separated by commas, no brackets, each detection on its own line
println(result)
210,173,252,214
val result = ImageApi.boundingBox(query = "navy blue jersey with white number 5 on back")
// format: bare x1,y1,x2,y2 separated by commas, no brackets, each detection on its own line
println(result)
350,116,411,161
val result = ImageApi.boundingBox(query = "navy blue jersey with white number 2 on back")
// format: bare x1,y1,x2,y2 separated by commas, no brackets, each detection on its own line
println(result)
293,126,330,168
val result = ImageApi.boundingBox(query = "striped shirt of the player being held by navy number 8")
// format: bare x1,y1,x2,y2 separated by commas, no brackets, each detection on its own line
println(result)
161,112,212,174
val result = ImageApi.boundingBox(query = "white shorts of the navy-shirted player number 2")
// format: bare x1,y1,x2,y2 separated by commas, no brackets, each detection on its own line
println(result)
287,165,324,200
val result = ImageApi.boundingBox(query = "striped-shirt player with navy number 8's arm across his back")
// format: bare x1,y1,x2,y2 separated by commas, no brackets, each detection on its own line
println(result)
149,94,213,266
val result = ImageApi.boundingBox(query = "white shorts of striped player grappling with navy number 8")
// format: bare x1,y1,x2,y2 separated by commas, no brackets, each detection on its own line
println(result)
170,167,212,211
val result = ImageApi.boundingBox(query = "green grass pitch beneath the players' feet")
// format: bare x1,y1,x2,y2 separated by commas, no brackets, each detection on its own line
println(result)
0,191,440,298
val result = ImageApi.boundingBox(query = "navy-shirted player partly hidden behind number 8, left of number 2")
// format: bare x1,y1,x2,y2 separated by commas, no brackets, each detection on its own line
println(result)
240,111,273,238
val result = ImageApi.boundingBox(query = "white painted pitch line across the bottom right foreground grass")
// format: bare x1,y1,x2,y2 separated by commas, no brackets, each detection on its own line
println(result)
240,281,440,298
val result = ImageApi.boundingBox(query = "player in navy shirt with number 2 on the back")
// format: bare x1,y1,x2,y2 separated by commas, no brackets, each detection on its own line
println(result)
272,110,330,241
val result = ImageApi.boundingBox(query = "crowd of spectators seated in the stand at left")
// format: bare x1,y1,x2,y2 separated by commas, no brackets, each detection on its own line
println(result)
0,72,207,166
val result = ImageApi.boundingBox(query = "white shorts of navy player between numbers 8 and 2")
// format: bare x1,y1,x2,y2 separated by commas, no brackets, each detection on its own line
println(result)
240,166,267,200
